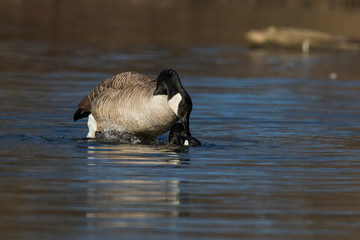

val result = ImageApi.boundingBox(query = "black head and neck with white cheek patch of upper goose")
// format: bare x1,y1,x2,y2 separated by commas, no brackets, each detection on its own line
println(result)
154,69,192,135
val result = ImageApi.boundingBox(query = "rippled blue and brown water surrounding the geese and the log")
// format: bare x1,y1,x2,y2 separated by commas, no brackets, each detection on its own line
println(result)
0,0,360,239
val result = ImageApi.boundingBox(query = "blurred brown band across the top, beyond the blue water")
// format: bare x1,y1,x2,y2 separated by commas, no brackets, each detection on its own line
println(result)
0,0,360,47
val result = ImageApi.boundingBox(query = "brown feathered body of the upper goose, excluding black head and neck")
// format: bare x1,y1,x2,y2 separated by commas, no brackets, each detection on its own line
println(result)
74,72,178,137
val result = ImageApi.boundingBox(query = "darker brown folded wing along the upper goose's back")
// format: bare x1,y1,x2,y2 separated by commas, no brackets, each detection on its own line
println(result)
74,72,156,121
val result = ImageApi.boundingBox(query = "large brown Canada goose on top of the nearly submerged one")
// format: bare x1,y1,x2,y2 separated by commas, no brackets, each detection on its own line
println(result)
74,69,192,141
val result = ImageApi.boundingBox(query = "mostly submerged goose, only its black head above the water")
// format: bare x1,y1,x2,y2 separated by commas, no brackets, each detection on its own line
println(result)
169,123,201,146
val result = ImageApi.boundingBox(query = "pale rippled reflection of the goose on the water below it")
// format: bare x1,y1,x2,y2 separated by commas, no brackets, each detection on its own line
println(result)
86,144,189,228
